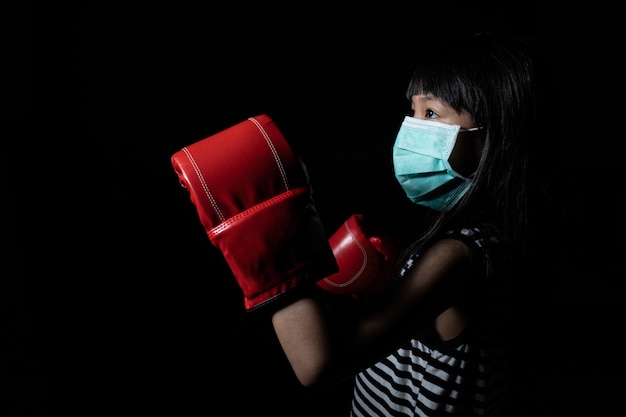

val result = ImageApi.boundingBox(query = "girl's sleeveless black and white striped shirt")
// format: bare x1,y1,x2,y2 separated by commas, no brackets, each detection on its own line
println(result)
350,228,508,417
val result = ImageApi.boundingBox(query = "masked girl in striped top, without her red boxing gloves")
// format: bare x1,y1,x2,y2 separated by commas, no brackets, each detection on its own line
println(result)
272,33,554,417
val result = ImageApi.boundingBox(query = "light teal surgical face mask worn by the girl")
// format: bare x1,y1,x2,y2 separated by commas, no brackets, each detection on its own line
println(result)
393,116,478,211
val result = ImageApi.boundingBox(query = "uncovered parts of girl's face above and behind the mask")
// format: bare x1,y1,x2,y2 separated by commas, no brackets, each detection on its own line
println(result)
411,95,484,176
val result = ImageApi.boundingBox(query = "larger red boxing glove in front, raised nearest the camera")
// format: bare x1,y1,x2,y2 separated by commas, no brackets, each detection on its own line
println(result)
171,115,338,311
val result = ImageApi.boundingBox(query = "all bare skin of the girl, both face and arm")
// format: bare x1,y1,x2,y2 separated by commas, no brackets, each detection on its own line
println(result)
272,95,481,386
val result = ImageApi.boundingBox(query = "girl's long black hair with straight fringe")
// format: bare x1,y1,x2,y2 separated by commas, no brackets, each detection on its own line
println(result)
406,32,556,252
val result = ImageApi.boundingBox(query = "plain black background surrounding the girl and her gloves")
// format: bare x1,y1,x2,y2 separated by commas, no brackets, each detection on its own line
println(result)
0,1,626,416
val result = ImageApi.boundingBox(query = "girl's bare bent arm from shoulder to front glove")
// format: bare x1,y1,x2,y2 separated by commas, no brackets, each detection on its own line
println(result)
272,239,471,386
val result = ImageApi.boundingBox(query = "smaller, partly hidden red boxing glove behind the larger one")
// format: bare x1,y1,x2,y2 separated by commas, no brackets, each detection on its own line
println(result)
317,214,400,299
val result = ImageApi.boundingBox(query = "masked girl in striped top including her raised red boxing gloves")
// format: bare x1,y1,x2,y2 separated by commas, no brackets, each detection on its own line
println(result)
172,28,556,417
